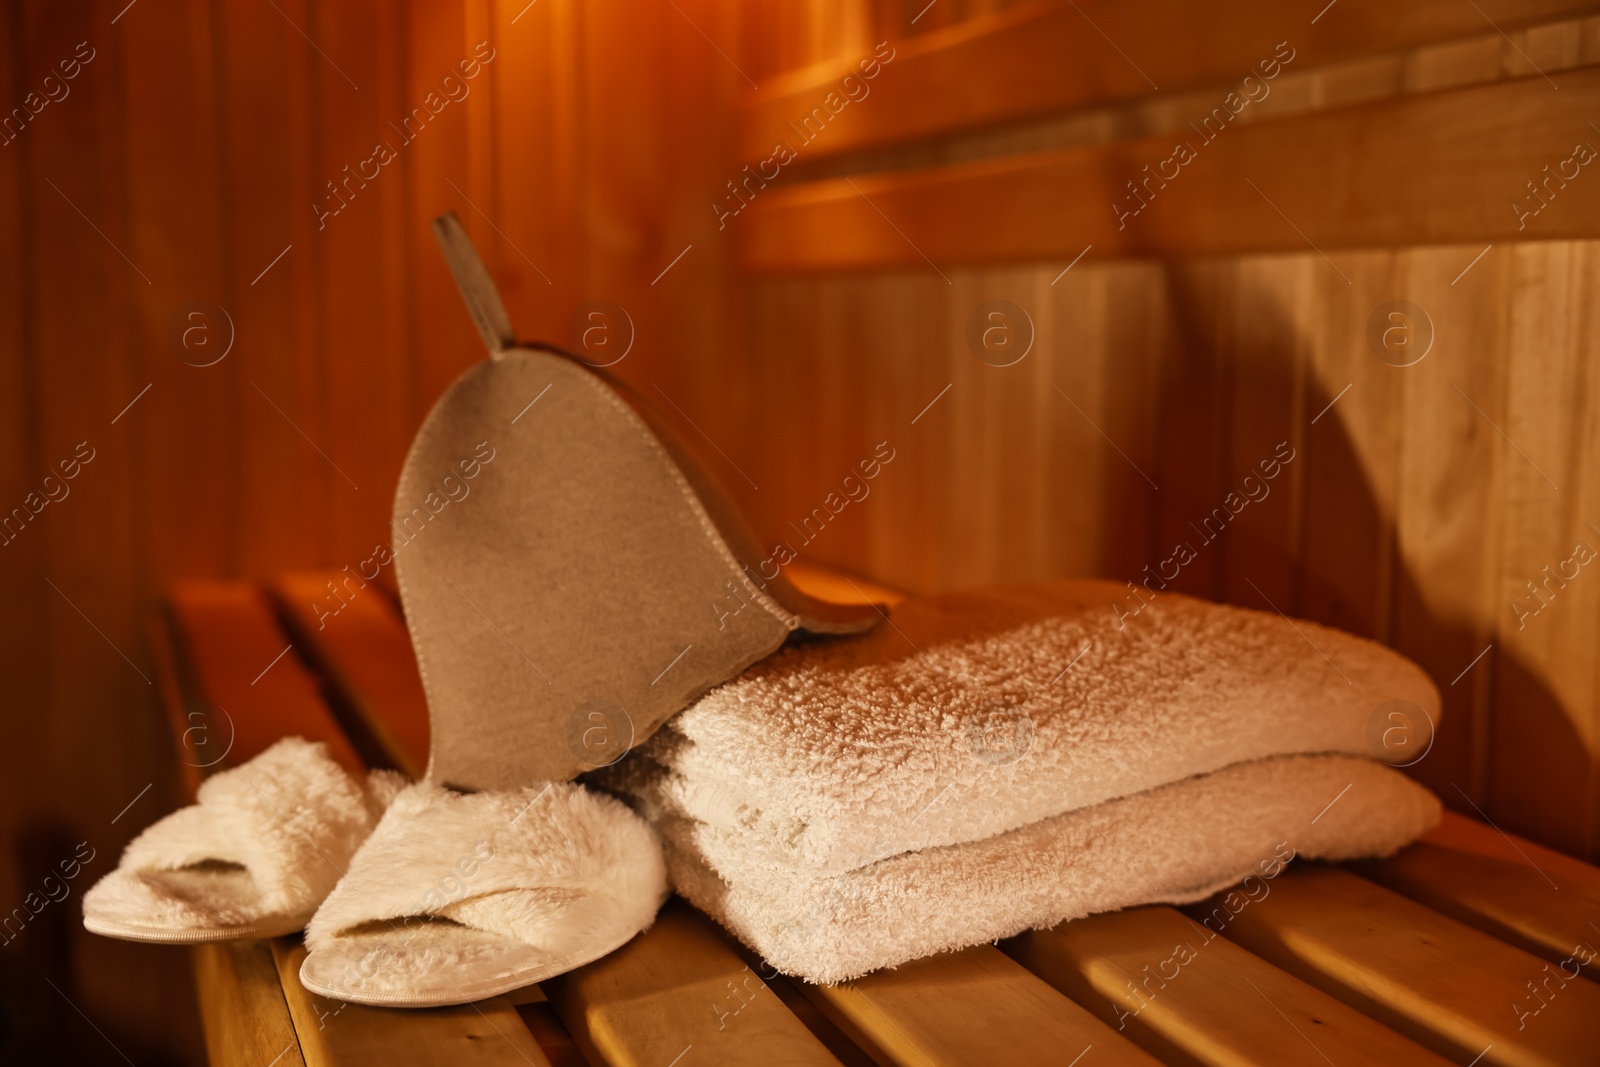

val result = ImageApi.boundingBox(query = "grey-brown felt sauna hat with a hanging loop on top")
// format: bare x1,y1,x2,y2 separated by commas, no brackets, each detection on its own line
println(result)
394,213,880,790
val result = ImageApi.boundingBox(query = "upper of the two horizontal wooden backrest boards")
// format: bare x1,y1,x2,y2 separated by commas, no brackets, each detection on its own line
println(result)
739,0,1595,163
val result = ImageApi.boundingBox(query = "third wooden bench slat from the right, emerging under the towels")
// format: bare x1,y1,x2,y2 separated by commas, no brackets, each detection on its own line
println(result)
1002,907,1445,1067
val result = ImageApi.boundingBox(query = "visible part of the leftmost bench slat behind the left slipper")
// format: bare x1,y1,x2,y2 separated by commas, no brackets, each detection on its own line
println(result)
168,582,365,773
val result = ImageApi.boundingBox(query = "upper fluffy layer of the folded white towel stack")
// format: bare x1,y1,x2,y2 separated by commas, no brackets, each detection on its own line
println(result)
600,581,1438,873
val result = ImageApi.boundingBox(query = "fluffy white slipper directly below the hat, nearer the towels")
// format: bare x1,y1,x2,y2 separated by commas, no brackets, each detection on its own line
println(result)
301,782,667,1008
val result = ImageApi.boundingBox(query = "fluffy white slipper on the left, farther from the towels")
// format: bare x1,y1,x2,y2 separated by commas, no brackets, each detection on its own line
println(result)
83,737,405,944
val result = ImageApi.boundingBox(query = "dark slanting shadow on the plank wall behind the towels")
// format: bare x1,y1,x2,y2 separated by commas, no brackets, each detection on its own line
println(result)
1152,266,1592,859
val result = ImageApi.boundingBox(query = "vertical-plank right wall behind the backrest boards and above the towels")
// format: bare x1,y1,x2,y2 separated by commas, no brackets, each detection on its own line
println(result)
723,0,1600,857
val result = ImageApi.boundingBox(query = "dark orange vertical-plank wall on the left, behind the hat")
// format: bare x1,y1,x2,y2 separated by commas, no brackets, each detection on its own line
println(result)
0,0,739,1064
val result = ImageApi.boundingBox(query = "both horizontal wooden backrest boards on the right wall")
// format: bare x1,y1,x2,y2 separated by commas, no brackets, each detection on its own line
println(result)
732,0,1600,274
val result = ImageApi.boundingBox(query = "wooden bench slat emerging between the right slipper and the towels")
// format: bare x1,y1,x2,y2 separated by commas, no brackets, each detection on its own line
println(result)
544,899,838,1067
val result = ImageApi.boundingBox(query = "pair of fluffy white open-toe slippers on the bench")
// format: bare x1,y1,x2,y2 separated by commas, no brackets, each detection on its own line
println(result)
83,737,667,1008
